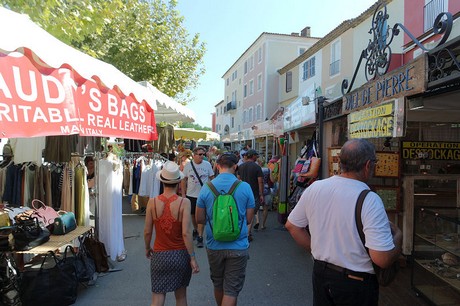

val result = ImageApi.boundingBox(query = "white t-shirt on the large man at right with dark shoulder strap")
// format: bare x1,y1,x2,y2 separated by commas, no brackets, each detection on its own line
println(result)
288,176,395,273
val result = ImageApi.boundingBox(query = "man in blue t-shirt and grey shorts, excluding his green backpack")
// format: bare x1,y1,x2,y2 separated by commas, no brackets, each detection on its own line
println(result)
196,153,254,306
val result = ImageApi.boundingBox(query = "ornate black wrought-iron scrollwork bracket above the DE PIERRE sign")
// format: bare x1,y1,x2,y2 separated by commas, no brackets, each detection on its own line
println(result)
342,5,453,95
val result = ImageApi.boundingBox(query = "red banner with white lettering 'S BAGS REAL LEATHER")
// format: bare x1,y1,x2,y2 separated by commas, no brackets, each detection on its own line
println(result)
0,52,157,140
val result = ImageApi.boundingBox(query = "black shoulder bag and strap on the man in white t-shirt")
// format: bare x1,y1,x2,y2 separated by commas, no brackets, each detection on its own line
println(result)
355,189,399,287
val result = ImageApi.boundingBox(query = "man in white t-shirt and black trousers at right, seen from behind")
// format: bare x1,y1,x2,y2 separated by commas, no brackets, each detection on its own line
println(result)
286,139,402,306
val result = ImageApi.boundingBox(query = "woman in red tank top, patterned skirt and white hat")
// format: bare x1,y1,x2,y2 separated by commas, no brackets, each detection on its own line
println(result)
144,161,200,306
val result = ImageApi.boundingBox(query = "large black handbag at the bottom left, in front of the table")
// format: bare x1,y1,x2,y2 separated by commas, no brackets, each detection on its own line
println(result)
20,251,78,306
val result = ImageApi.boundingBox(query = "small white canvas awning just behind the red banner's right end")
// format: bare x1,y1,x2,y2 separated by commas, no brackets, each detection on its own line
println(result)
139,81,195,123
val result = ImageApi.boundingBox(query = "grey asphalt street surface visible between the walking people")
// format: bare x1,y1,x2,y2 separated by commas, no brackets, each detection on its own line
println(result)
75,200,312,306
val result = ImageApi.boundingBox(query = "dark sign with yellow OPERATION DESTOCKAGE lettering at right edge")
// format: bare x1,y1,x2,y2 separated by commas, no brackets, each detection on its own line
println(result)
402,141,460,161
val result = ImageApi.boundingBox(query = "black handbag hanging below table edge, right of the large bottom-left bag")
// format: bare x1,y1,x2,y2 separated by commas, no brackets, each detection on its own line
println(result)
62,243,96,283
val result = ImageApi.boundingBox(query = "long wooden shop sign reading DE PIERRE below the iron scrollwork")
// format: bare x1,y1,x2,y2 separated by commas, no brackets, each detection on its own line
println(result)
343,56,426,114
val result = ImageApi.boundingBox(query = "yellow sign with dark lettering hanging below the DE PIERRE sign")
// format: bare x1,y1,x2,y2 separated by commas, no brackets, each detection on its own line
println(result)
348,100,404,138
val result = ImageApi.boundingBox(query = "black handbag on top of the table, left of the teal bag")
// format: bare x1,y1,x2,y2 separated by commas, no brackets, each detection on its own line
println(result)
13,218,50,251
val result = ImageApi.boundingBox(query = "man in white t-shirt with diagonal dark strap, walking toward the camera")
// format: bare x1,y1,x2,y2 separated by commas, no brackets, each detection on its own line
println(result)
181,147,214,248
